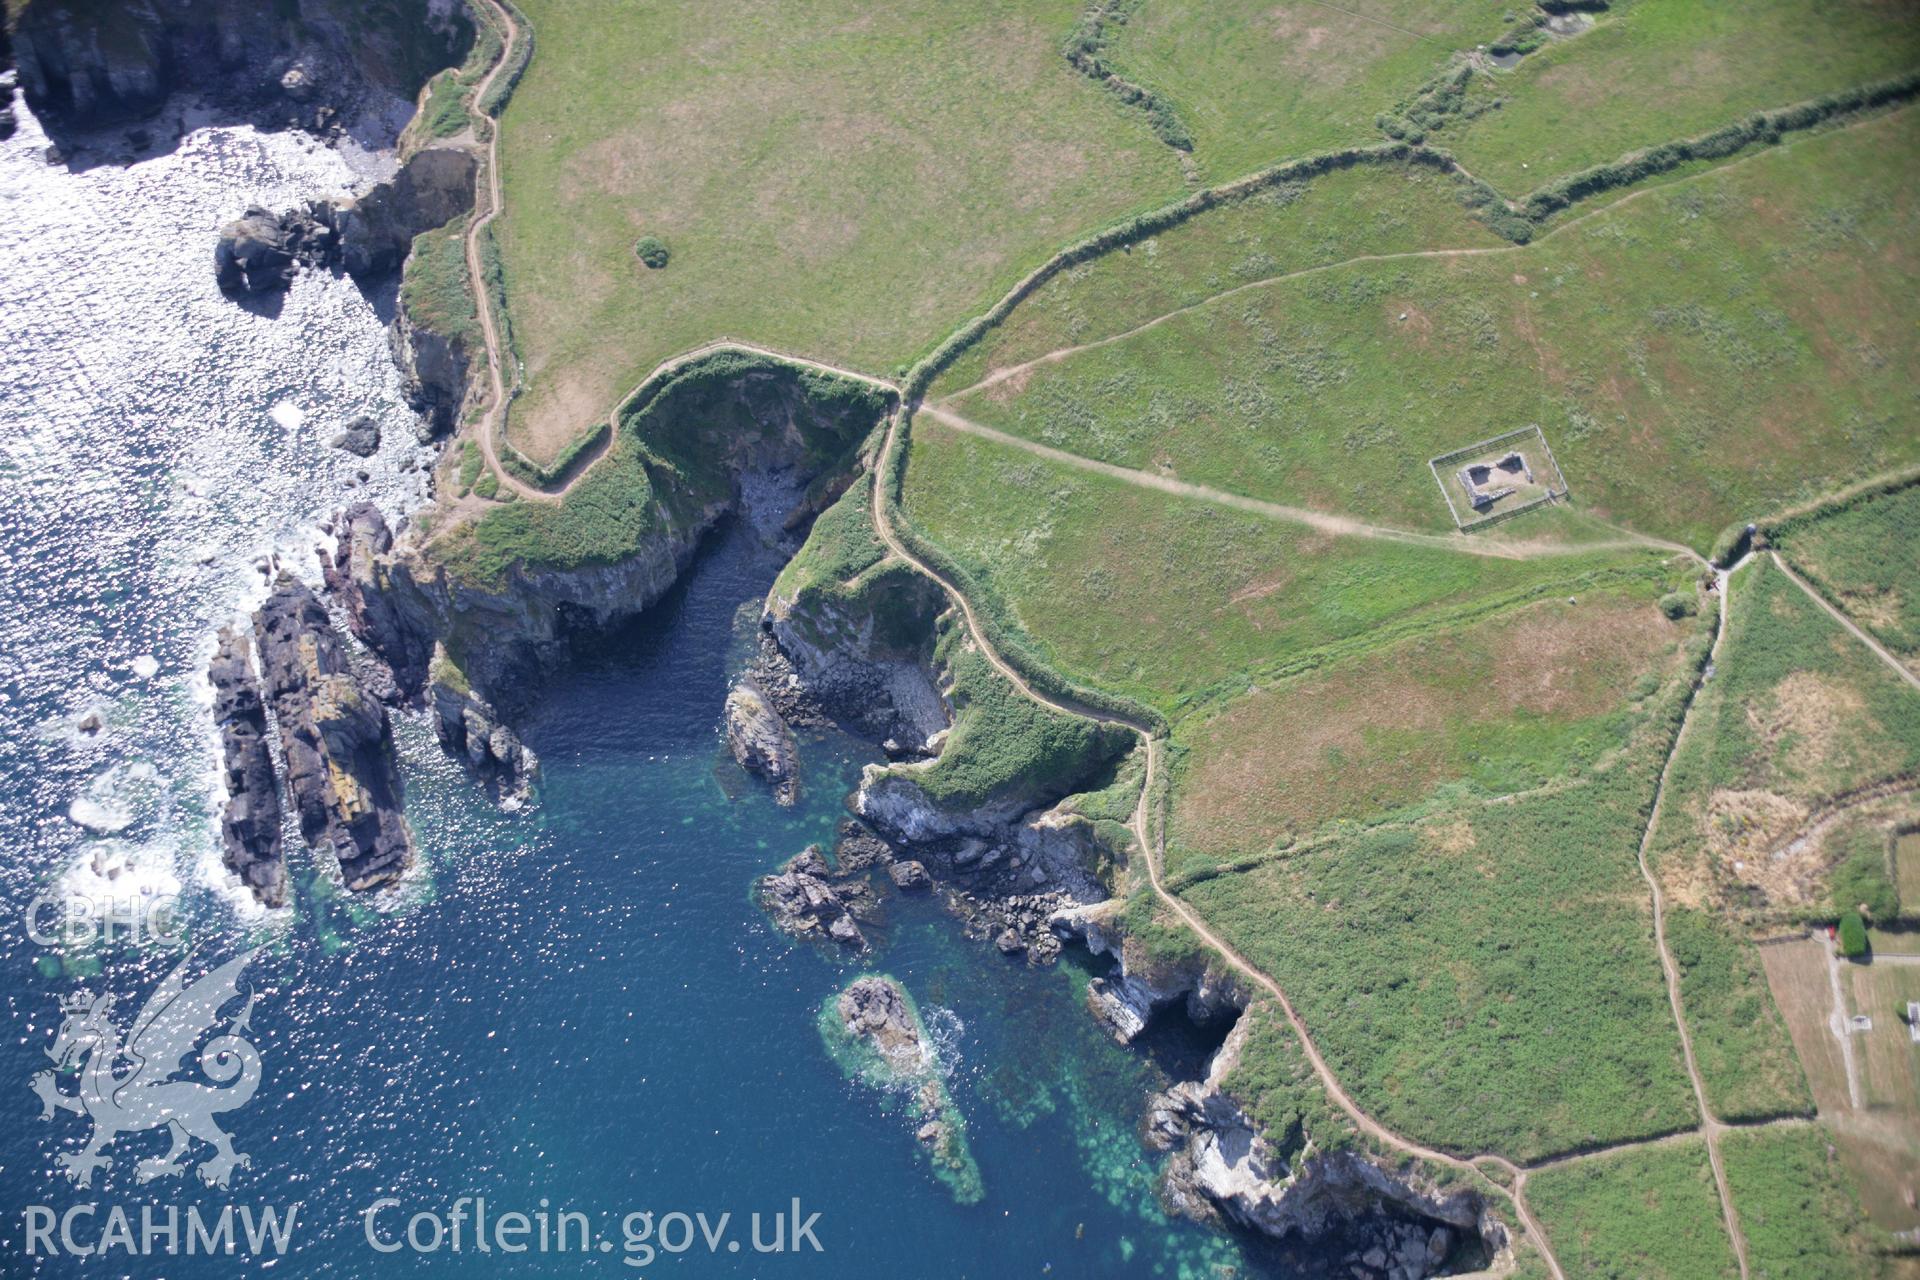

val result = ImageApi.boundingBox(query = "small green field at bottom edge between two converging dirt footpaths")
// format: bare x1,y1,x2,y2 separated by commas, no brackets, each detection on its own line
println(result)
1526,1138,1740,1280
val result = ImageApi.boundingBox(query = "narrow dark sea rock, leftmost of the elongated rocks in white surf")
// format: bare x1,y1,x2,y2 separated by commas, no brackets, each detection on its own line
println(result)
207,628,286,906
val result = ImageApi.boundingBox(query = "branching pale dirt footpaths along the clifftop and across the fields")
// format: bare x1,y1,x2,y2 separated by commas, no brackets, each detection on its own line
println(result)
357,0,1920,1280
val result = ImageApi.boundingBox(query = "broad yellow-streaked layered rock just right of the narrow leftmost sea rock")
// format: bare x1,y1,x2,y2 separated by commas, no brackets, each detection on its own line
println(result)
253,572,413,890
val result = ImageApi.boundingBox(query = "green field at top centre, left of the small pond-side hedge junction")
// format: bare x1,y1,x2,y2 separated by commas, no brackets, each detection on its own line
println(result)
1112,0,1509,180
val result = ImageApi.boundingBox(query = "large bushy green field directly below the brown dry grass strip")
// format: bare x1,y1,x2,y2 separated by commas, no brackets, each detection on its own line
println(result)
1181,750,1697,1161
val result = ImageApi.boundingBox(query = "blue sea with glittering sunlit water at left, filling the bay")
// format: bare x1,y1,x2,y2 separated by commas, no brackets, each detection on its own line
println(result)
0,97,1290,1278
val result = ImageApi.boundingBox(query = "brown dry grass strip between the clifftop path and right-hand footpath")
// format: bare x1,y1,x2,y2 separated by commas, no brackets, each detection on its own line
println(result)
1173,591,1682,856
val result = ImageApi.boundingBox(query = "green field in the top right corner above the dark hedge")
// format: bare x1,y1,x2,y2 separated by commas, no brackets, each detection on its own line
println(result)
1432,0,1920,198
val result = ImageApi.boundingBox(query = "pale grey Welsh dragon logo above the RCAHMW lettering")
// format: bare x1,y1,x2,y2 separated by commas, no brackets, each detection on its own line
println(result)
33,950,261,1186
